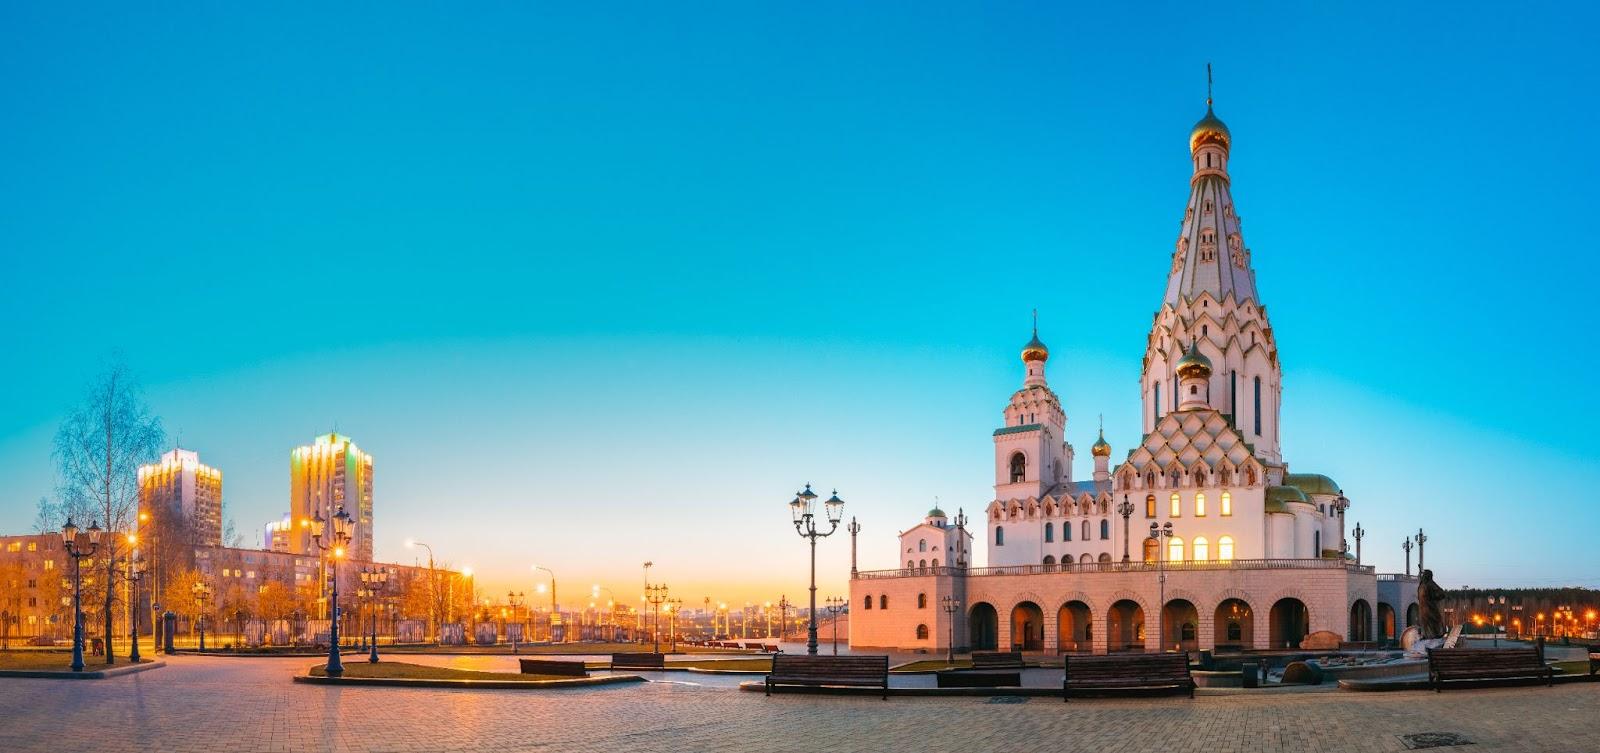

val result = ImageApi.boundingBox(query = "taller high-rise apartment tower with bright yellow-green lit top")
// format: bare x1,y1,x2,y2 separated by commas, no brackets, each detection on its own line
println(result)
288,433,373,561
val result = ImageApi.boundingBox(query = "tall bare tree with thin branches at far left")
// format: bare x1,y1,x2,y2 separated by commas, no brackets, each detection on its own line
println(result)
52,363,165,663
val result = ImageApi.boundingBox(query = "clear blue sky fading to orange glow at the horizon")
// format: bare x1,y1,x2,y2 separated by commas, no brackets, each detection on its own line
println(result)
0,3,1600,601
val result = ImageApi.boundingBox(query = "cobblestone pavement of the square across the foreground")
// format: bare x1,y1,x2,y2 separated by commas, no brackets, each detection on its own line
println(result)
0,657,1600,753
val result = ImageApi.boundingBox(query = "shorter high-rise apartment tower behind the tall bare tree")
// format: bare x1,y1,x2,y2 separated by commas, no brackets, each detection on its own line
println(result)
139,448,222,547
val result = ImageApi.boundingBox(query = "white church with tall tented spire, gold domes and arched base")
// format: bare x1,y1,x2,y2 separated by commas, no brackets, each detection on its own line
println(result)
850,101,1414,654
